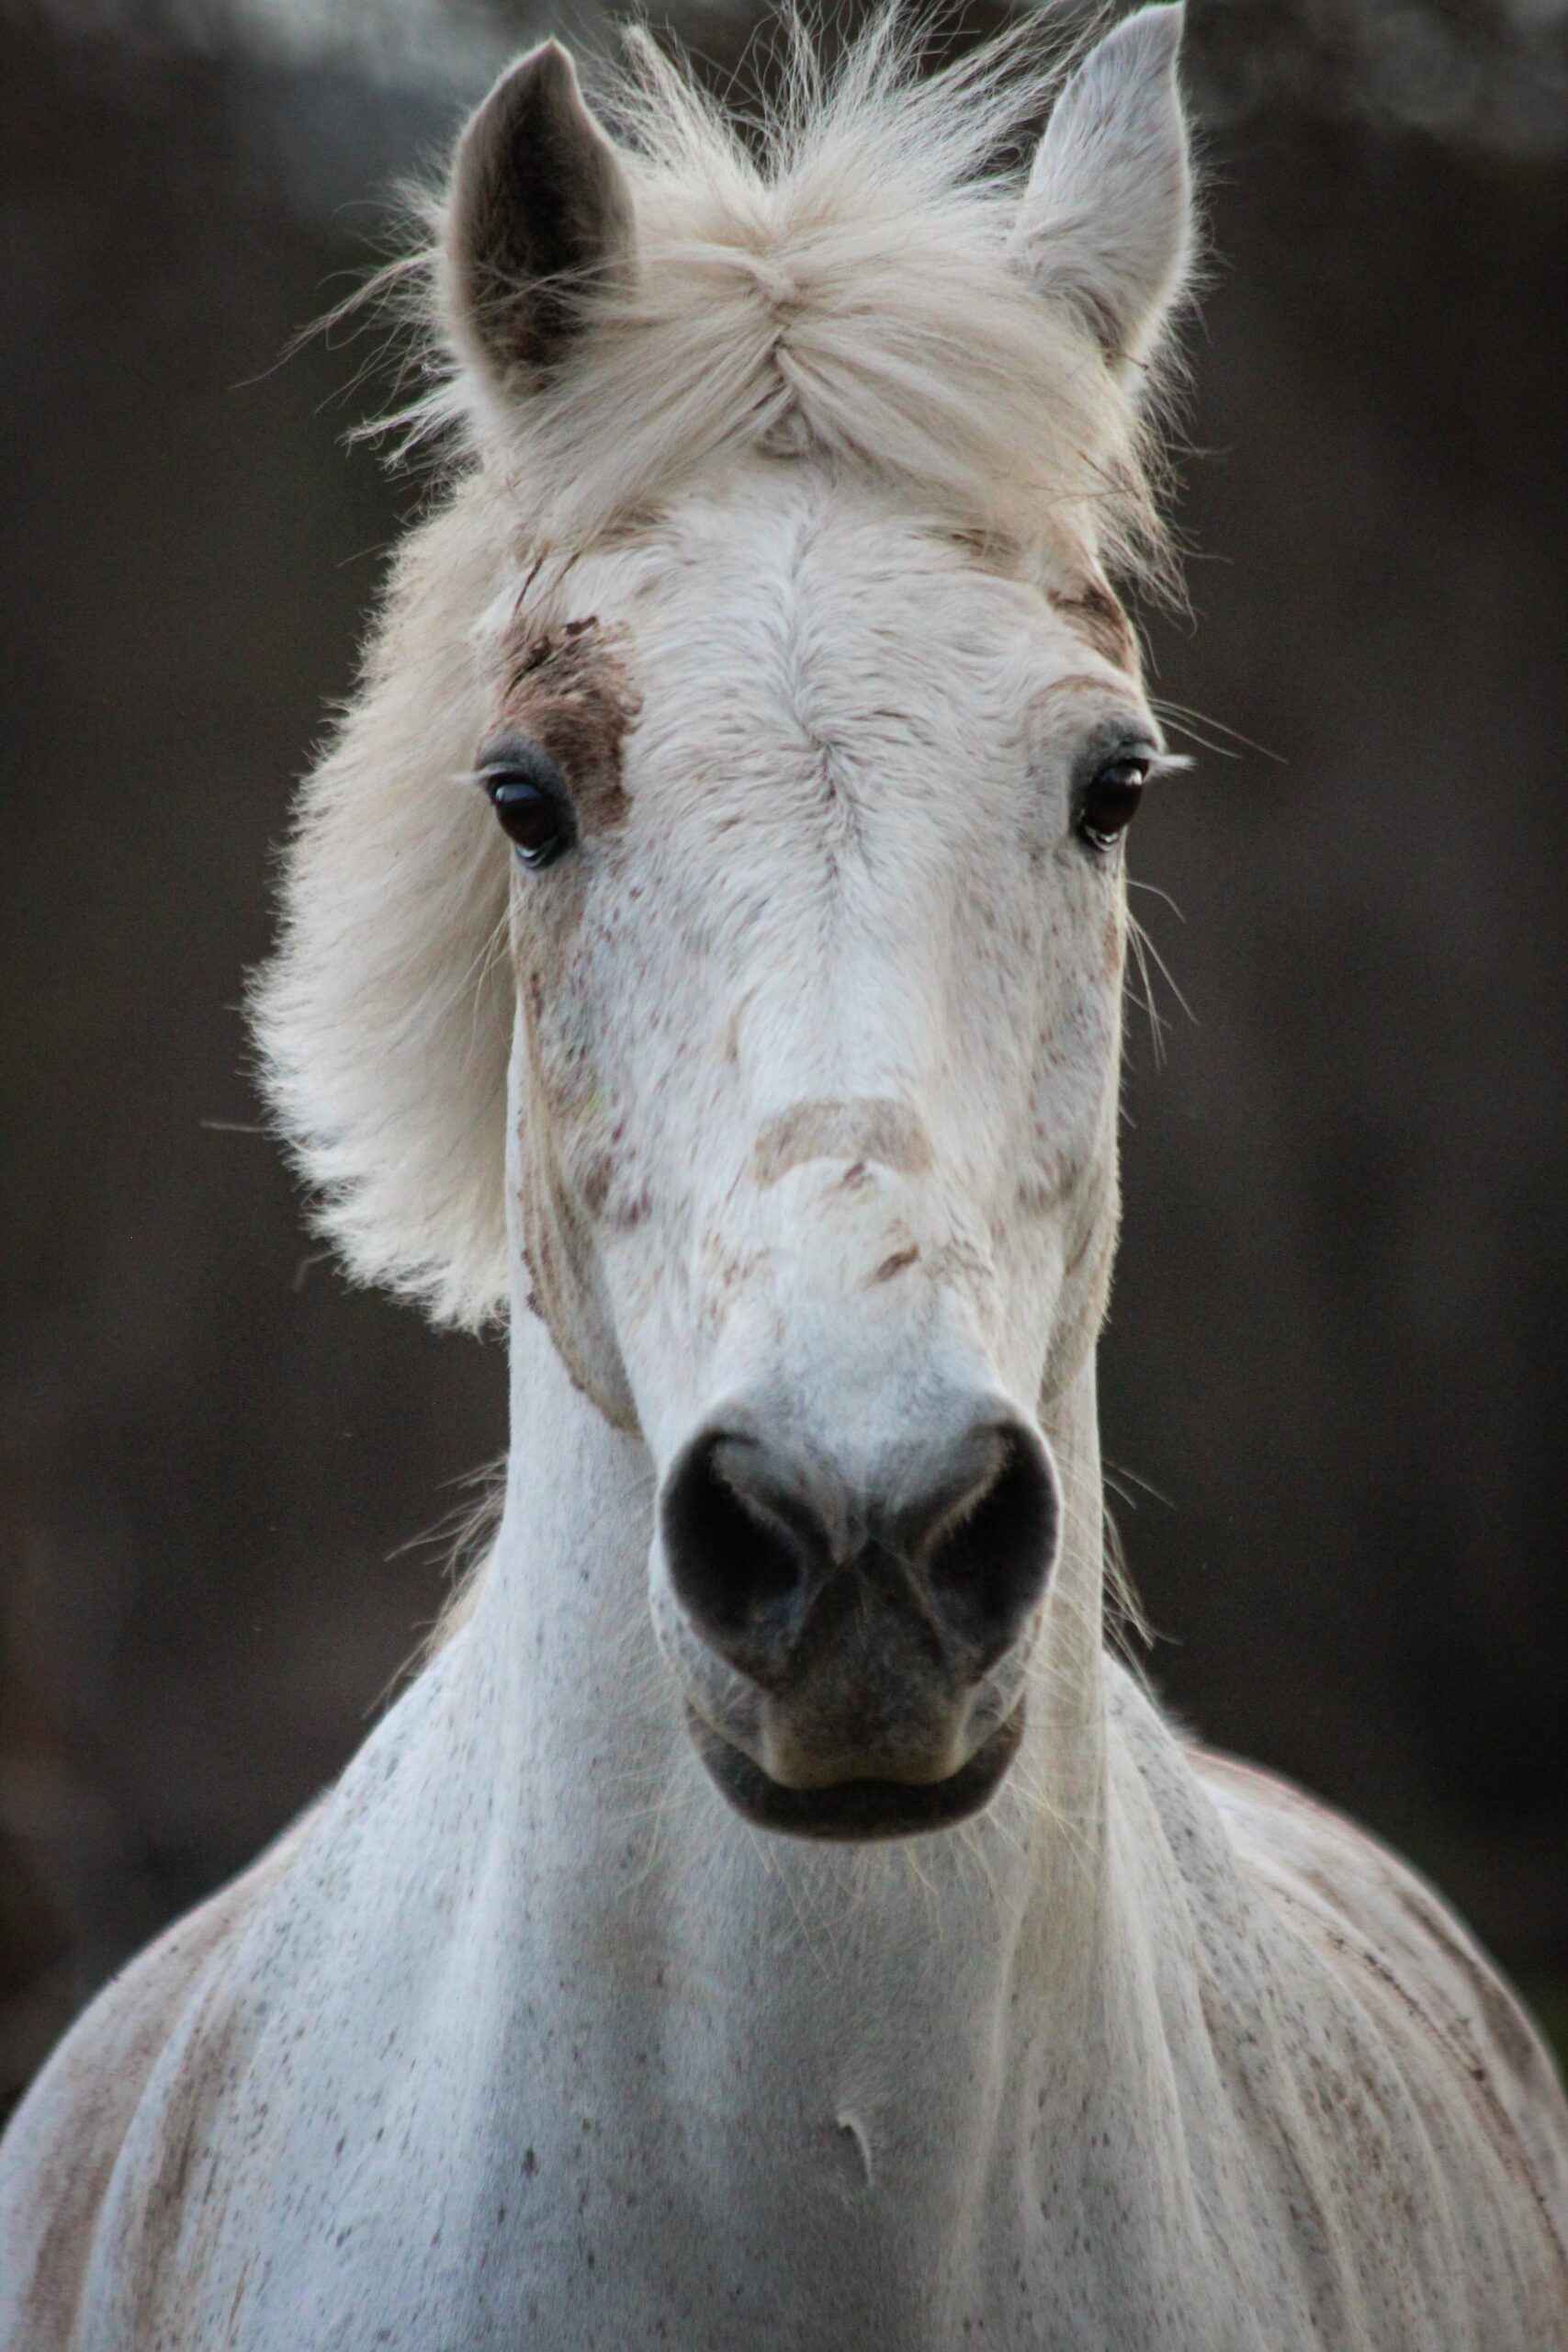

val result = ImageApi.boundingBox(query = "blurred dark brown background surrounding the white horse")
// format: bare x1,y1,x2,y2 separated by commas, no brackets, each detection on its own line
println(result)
0,0,1568,2105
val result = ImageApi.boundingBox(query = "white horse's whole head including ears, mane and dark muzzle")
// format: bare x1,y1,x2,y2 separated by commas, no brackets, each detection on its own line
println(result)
264,7,1190,1837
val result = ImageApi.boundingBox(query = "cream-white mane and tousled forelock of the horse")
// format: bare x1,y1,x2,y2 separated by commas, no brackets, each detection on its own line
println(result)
254,14,1189,1324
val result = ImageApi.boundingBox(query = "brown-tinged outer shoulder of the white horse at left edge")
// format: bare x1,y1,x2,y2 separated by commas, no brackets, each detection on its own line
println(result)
0,1814,312,2352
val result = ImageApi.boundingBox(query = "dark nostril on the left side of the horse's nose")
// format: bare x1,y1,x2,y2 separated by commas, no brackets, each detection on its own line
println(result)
660,1430,823,1675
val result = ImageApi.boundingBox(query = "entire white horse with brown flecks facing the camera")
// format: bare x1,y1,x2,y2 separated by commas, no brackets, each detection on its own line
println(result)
0,7,1568,2352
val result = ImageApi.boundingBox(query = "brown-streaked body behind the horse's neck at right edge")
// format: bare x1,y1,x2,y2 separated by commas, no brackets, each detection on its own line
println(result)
1187,1747,1568,2310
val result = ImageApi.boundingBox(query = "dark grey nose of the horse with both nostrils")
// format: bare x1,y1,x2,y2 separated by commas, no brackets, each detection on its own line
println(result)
660,1399,1058,1689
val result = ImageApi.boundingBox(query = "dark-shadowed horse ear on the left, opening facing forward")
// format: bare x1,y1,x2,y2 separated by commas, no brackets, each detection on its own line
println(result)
442,40,635,390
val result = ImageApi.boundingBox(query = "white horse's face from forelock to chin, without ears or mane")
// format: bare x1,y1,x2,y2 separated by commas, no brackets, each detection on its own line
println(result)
491,477,1159,1837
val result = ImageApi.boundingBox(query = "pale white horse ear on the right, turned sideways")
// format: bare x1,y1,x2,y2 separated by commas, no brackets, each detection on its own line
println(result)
1013,7,1192,367
